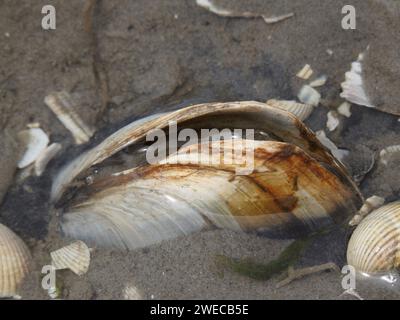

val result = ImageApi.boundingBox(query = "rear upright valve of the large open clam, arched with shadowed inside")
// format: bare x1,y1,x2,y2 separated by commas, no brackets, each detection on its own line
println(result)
51,101,352,202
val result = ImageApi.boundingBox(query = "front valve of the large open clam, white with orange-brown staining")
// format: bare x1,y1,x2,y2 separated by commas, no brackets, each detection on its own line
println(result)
62,140,358,249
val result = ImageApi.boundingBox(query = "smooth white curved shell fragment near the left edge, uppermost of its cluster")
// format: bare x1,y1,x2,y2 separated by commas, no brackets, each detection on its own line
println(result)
18,128,49,169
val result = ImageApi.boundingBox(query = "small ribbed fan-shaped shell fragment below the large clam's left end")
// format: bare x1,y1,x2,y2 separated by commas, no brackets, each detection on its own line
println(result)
50,241,90,276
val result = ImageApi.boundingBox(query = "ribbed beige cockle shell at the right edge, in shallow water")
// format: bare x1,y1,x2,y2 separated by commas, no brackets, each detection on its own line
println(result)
347,201,400,274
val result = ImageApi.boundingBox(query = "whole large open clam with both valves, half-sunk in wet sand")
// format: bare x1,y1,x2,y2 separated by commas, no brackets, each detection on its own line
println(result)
52,102,361,249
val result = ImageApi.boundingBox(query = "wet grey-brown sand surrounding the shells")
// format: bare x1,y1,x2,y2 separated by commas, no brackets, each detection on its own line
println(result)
0,0,400,299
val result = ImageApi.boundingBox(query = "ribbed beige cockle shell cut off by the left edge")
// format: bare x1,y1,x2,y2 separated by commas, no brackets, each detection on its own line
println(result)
0,224,31,298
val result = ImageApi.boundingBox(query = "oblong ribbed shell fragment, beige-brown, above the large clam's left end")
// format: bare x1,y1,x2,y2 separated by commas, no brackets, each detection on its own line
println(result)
44,91,94,144
